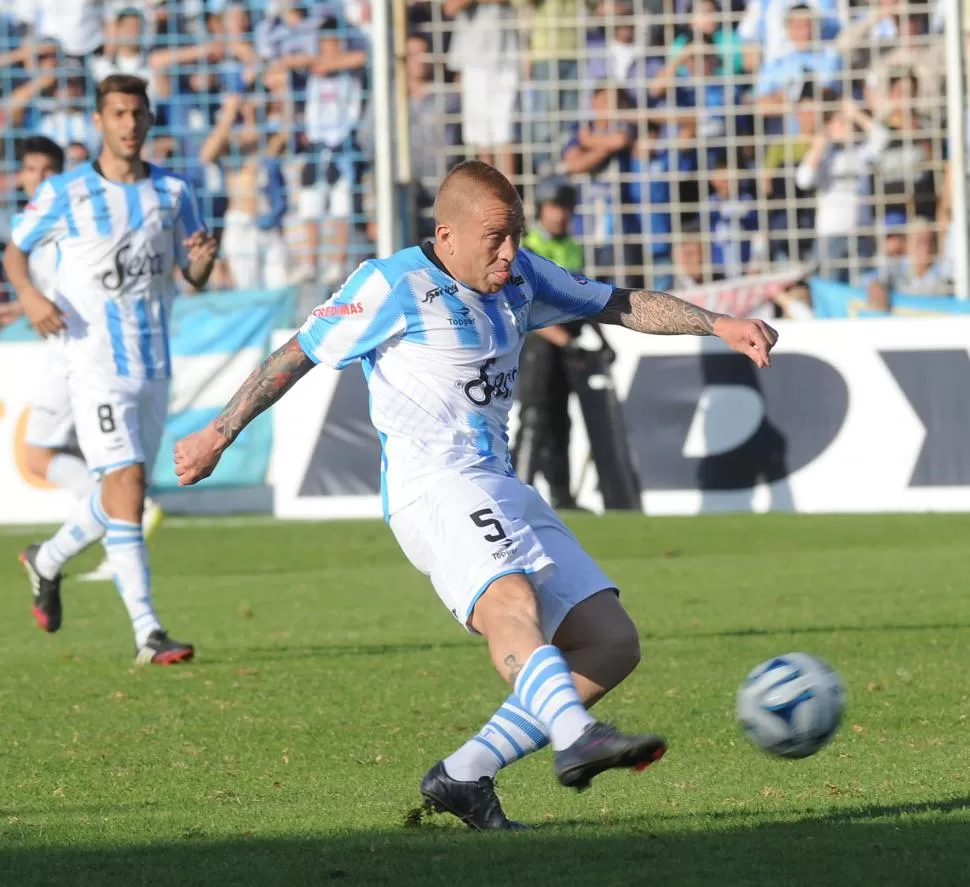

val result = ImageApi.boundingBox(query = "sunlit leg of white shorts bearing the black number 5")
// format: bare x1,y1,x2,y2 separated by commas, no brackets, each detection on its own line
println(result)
391,473,553,627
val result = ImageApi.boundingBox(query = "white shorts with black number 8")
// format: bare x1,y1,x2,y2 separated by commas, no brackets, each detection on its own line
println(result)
71,379,170,477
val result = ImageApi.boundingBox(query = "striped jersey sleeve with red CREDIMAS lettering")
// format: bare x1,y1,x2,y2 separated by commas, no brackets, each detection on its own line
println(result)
296,262,407,370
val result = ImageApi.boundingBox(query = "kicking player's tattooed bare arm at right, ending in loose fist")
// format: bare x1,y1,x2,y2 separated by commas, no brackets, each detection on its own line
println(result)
596,288,778,367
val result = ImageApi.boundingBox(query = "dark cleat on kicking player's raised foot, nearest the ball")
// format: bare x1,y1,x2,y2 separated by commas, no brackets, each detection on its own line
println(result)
556,721,667,791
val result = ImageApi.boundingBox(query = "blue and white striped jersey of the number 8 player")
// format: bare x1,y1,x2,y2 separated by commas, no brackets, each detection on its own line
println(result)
12,163,203,383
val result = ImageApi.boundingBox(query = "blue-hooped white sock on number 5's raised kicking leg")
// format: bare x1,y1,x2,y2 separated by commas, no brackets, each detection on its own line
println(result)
515,644,594,751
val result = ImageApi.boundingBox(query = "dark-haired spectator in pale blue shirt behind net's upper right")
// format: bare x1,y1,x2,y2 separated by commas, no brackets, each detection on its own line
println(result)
755,3,840,114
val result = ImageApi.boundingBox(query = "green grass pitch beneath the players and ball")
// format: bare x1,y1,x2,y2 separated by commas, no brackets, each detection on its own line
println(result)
0,516,970,887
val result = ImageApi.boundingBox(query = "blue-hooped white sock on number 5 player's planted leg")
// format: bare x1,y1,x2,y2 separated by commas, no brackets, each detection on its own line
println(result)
444,693,549,782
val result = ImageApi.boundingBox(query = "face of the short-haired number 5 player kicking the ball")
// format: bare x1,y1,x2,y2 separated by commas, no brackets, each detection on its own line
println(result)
452,197,525,293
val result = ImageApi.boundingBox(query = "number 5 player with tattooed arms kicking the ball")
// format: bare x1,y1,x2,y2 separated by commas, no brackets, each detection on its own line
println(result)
175,161,777,829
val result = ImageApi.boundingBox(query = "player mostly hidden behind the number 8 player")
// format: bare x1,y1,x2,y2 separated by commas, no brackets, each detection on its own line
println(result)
14,135,162,580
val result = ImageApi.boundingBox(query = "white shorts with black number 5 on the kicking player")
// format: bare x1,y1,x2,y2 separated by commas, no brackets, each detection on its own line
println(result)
390,472,615,641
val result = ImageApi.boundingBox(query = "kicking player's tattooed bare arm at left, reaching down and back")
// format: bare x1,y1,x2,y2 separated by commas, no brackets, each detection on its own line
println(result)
175,336,316,487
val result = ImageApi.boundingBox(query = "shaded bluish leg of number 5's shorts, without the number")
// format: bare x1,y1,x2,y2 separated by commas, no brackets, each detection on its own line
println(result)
526,487,616,641
